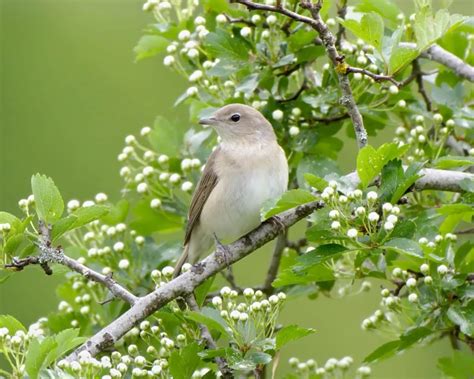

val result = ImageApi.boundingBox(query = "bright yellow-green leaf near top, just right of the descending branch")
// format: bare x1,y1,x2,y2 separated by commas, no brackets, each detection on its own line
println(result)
339,12,384,51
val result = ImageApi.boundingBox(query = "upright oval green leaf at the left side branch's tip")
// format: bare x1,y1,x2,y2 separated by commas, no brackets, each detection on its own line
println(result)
31,174,64,224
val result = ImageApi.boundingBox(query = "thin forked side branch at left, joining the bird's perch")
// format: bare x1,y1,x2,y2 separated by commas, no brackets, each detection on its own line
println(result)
5,222,138,305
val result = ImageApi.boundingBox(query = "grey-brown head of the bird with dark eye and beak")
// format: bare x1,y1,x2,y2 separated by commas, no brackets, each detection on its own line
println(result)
199,104,275,143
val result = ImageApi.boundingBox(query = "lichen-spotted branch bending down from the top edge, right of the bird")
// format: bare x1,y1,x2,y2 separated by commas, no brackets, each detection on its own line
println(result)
231,0,367,148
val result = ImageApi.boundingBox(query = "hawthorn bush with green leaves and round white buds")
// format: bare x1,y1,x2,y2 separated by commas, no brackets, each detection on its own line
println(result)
0,0,474,379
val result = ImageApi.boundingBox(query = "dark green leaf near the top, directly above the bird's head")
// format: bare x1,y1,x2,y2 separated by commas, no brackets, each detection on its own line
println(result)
204,30,249,63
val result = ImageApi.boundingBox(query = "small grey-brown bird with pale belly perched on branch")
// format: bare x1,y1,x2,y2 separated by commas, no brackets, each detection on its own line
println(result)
174,104,288,277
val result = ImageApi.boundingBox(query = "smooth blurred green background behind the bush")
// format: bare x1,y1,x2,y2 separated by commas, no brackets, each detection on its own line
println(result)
0,0,473,378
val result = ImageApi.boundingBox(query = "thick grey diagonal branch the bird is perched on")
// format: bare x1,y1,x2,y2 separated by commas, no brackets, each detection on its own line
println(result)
68,169,474,360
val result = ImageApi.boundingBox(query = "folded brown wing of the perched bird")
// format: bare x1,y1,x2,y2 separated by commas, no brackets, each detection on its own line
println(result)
184,148,220,245
